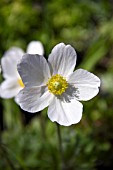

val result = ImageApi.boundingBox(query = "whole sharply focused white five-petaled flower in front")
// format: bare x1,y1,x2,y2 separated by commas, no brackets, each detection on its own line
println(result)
17,43,100,126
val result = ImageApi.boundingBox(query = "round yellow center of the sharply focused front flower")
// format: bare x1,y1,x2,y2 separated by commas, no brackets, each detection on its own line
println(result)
47,74,68,95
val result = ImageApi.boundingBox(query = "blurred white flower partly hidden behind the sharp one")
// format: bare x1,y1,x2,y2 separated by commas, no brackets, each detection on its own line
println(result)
1,41,44,98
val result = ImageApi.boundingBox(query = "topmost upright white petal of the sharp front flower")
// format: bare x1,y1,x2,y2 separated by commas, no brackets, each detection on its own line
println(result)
48,43,77,76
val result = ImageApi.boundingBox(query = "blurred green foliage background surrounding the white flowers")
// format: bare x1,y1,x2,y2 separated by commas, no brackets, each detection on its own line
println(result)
0,0,113,170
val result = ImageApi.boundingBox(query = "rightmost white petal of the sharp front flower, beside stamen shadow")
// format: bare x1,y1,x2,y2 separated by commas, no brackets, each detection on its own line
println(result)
68,69,100,101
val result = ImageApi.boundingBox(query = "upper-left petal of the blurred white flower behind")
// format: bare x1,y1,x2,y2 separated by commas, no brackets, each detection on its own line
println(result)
1,47,24,78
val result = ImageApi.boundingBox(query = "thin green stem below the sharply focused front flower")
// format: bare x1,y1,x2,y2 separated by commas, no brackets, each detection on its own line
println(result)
56,123,65,170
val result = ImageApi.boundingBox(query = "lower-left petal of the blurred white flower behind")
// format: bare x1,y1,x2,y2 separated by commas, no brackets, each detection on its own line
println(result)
0,79,22,99
